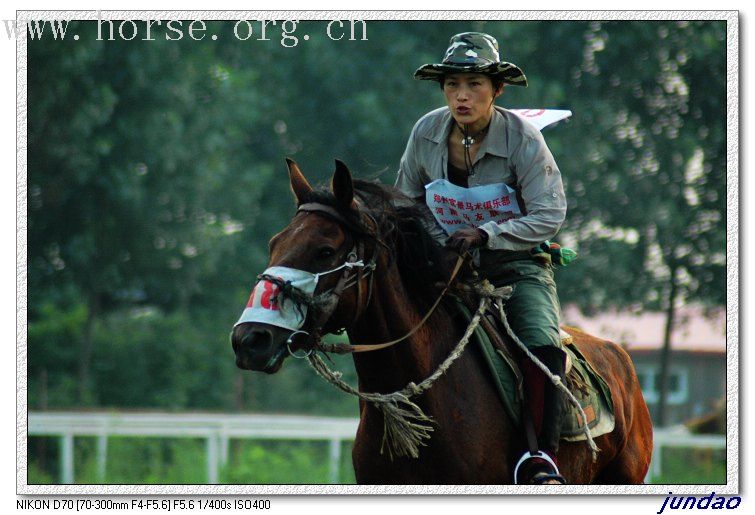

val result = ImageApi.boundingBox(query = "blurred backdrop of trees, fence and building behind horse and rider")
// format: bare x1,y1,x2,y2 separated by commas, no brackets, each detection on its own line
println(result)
27,21,727,484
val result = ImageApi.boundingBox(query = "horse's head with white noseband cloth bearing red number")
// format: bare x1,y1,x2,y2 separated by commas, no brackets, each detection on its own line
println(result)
231,159,376,374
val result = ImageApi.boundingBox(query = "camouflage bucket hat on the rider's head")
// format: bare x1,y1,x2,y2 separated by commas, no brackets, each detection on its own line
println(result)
414,32,527,86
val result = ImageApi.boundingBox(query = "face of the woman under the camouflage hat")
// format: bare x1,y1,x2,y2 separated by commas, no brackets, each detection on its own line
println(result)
443,73,500,126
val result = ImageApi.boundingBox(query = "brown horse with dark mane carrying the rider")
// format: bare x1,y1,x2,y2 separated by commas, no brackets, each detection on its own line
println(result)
231,160,652,484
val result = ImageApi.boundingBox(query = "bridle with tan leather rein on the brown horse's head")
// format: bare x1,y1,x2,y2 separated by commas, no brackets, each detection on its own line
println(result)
272,202,464,358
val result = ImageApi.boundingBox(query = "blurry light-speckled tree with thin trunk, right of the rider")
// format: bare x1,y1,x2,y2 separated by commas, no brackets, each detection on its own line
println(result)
552,21,726,425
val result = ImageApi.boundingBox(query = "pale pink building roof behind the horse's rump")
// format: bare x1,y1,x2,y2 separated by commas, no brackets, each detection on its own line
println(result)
562,305,726,352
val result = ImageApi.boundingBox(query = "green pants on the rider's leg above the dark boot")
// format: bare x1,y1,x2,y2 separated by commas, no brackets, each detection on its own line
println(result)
480,253,562,349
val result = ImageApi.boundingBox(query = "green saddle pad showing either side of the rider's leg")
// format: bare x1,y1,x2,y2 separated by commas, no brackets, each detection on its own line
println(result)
456,302,615,441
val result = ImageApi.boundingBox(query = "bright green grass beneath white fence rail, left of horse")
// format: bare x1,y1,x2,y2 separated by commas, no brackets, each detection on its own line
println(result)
28,437,354,485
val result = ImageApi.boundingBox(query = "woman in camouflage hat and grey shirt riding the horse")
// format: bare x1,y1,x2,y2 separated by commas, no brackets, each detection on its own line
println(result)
396,32,566,484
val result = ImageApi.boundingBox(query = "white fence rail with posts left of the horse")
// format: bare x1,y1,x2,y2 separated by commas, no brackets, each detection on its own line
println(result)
28,412,359,484
